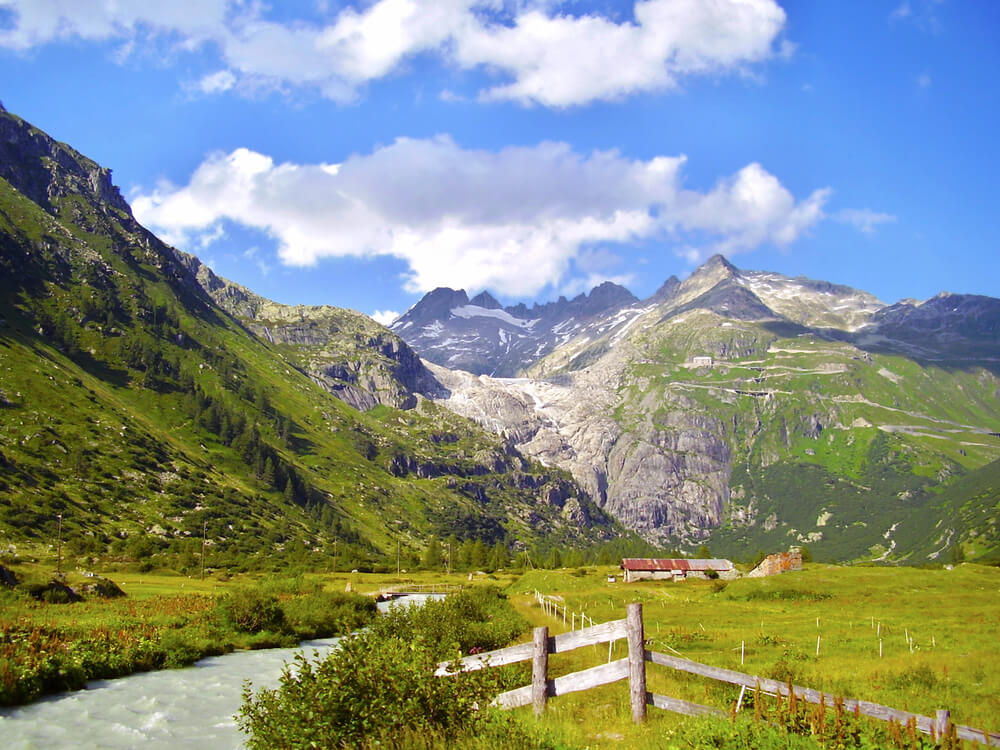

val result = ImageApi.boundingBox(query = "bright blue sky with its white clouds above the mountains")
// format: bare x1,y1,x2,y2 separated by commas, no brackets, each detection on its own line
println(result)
0,0,1000,320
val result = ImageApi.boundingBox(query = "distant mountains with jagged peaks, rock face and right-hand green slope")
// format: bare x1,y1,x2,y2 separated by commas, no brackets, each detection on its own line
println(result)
391,256,1000,562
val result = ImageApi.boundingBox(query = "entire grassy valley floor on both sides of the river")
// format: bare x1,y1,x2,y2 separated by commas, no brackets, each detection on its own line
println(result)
0,564,1000,748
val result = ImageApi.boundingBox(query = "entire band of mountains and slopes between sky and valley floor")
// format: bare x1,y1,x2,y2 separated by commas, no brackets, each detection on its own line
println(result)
0,106,1000,564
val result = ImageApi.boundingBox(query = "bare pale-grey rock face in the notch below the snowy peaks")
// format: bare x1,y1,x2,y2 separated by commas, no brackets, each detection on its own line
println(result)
429,332,730,542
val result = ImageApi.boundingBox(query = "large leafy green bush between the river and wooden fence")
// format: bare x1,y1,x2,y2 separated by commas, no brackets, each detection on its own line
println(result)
238,588,532,750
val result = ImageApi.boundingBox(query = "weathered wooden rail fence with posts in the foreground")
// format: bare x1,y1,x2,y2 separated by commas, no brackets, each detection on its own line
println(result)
436,603,1000,747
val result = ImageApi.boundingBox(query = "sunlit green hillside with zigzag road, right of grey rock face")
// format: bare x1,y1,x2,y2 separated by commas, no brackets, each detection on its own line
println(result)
617,311,1000,564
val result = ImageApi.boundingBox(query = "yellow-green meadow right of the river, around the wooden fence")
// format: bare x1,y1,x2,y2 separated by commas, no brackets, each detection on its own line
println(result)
509,565,1000,748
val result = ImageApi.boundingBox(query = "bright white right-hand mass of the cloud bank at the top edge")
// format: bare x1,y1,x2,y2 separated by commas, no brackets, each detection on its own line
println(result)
455,0,785,107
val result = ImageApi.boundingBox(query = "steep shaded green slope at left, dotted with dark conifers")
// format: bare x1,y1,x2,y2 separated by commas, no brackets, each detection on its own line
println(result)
0,112,615,566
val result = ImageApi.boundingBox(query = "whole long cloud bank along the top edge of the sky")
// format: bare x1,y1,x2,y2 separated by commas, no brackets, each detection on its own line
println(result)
0,0,793,107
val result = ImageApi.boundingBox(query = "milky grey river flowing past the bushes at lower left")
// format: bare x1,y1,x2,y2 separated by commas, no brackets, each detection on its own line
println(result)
0,597,438,750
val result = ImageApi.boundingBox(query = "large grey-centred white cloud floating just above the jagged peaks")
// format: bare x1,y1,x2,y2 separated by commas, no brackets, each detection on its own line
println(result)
133,136,829,297
